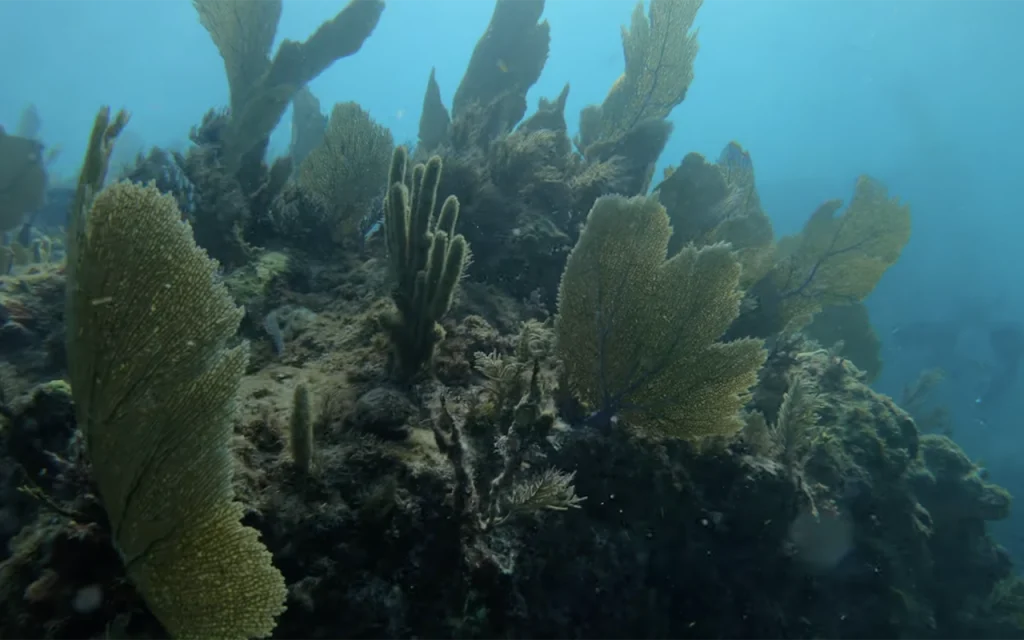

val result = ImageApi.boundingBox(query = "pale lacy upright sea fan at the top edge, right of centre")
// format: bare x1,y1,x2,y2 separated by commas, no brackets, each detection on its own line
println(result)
580,0,702,148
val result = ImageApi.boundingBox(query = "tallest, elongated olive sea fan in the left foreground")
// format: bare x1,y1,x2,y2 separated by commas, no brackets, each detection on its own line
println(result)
67,109,287,640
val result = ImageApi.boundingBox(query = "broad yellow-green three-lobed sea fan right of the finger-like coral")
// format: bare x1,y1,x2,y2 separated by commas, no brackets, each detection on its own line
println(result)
555,192,765,437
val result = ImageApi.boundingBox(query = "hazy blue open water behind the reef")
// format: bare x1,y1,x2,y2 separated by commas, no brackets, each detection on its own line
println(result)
0,0,1024,558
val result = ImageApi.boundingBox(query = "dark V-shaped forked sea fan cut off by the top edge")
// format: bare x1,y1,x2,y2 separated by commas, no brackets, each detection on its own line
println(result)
193,0,384,172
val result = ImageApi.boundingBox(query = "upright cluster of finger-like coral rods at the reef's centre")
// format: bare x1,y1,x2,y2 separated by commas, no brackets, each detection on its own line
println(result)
384,146,469,379
